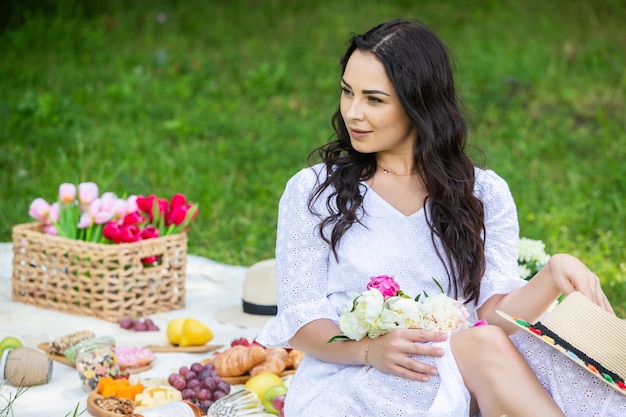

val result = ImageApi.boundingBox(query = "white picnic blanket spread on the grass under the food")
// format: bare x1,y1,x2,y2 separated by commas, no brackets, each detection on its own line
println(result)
0,243,270,417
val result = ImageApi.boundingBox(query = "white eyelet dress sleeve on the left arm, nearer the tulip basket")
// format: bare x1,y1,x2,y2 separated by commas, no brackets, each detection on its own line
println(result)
252,166,338,347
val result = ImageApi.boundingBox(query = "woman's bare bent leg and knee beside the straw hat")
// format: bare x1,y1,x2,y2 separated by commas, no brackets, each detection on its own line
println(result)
450,326,565,417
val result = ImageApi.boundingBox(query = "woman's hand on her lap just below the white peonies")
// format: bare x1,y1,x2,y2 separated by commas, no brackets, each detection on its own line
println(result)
367,329,448,381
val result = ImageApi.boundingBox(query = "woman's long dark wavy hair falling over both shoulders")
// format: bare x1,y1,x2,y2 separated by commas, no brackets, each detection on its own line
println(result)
309,19,485,303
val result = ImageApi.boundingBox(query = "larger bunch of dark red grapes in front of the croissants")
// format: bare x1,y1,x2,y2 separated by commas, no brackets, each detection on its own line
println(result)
167,362,230,412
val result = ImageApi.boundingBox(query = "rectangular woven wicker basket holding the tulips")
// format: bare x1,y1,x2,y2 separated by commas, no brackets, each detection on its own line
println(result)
12,223,187,321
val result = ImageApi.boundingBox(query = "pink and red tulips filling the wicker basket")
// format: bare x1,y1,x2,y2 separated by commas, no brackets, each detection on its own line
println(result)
29,182,198,243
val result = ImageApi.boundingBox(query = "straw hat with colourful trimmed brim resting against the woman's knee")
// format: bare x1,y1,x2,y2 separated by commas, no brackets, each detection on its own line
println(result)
498,291,626,395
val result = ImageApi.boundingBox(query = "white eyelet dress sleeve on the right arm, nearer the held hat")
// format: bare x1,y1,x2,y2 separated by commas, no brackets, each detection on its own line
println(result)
476,170,526,308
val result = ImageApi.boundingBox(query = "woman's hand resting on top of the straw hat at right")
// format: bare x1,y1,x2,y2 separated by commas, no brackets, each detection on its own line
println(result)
546,253,614,313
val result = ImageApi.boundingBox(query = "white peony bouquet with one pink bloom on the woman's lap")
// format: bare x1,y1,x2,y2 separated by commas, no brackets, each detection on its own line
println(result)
329,275,476,342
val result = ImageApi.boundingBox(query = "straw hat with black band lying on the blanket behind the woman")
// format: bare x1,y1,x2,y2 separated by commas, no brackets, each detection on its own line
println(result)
215,259,277,327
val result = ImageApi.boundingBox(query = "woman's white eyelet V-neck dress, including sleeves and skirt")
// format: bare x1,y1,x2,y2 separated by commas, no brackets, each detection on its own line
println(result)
257,164,626,417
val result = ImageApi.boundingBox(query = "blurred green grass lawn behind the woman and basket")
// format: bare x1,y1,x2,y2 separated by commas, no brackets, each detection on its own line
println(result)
0,0,626,316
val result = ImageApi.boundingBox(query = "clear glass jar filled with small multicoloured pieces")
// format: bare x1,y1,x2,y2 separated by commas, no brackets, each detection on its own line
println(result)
76,340,120,391
